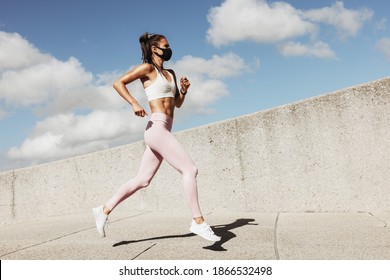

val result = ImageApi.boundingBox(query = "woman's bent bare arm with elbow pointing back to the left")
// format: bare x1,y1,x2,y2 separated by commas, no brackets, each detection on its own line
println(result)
113,63,153,117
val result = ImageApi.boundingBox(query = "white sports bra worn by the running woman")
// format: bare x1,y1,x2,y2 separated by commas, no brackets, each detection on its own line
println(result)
145,67,176,101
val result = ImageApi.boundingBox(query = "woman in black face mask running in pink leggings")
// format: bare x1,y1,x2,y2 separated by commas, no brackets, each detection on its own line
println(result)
93,33,221,241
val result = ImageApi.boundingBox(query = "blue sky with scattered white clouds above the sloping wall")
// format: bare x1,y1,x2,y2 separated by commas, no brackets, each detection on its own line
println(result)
0,0,390,170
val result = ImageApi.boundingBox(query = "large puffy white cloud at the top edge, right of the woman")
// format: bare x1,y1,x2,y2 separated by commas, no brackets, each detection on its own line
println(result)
207,0,317,46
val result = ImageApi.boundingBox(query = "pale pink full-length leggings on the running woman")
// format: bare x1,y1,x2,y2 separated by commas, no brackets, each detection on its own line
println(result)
106,113,202,218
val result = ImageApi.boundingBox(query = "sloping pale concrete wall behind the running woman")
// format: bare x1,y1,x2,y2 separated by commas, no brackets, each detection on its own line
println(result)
0,78,390,223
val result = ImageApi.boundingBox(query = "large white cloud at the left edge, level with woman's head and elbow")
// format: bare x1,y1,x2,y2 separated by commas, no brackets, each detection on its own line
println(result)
0,32,123,115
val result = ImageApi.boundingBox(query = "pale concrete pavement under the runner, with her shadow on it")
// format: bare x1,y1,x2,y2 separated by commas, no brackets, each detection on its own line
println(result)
0,210,390,260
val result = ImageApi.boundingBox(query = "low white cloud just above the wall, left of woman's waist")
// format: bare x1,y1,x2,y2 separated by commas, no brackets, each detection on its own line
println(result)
7,110,145,164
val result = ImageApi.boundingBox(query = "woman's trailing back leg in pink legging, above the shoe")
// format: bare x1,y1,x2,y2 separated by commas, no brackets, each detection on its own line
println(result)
105,146,163,214
